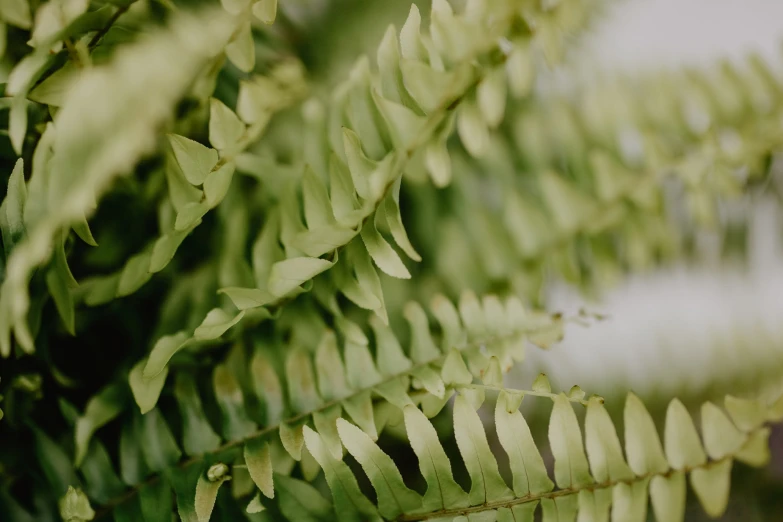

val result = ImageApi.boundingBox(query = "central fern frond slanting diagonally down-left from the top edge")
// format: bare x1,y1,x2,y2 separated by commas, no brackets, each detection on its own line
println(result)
129,1,600,370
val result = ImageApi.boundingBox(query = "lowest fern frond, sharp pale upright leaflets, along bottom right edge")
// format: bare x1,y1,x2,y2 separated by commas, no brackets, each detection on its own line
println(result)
306,380,783,522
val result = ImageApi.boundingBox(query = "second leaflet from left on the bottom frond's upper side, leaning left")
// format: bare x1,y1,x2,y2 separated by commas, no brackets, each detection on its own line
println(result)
337,419,421,519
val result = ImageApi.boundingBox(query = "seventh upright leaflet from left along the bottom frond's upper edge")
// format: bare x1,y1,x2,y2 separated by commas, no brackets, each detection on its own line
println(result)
585,399,633,482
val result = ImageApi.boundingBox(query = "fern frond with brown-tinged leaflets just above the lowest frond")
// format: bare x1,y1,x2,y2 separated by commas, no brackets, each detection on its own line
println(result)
64,293,560,513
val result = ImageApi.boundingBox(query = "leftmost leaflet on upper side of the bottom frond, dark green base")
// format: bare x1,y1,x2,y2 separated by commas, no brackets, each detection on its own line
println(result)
304,426,376,522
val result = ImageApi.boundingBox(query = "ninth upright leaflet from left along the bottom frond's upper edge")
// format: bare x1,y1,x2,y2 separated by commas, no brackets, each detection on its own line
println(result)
663,399,707,470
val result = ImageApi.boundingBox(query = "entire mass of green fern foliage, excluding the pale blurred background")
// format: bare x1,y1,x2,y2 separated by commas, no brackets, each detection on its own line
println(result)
0,0,783,522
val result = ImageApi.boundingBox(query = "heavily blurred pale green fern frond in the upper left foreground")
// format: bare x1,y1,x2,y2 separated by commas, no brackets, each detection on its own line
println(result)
0,13,239,357
